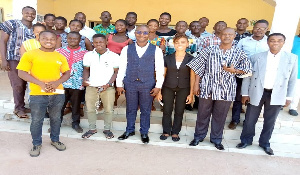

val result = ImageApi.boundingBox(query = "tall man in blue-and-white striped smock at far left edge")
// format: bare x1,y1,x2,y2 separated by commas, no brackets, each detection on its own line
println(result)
0,6,36,118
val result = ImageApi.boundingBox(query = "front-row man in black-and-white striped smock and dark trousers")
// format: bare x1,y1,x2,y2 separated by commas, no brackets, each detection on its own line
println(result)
187,28,252,150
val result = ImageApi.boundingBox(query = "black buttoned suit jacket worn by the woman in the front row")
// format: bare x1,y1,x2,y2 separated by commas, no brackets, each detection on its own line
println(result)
163,53,194,88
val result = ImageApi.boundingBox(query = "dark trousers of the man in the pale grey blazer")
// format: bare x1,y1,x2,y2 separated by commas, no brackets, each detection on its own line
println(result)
240,91,281,147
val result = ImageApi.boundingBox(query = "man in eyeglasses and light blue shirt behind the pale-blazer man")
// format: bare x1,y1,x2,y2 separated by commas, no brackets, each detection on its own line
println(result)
228,19,269,129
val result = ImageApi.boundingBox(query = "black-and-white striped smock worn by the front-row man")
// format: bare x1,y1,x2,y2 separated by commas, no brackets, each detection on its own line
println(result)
187,45,252,101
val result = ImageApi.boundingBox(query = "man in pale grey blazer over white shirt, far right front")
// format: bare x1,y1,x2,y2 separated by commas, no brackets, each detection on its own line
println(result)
236,33,298,155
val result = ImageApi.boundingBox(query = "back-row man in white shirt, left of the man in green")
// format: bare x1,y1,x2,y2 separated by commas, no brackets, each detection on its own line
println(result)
65,12,96,42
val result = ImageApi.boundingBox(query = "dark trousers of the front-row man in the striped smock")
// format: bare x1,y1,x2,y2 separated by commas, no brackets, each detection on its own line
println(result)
194,98,231,144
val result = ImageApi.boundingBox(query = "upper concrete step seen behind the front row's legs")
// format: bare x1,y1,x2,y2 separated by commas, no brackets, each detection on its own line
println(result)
0,100,300,136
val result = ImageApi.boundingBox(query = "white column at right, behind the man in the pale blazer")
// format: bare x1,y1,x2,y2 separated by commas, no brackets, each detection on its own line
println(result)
270,0,300,52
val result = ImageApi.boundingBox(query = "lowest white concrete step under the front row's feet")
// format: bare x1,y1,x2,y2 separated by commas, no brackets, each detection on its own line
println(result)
0,120,300,158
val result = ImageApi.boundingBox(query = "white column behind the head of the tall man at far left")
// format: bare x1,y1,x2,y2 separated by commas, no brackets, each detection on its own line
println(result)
12,0,37,23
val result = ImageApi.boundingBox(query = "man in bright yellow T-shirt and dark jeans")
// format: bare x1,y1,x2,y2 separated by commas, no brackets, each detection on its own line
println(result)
17,31,70,157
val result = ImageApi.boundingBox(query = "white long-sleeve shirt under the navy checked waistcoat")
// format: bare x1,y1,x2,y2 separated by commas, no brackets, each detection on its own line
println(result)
116,43,164,88
